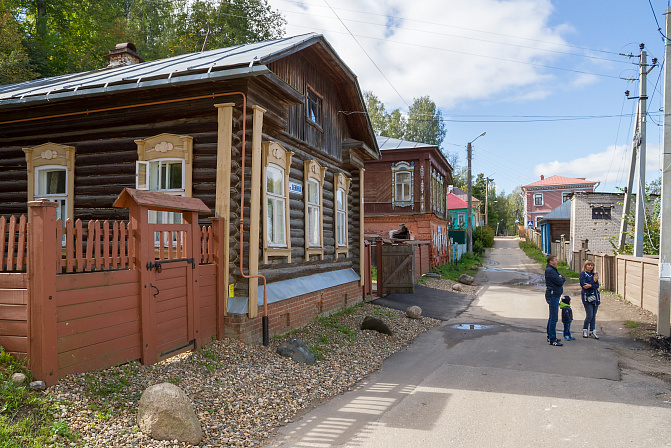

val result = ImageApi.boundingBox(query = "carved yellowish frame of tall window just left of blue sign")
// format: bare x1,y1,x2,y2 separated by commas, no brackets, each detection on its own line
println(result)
261,142,294,264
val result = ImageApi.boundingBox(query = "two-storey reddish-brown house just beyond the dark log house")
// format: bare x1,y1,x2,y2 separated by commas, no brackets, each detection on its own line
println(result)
364,136,452,266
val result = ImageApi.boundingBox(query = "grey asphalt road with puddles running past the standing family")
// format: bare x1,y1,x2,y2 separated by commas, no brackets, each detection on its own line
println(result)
271,238,671,448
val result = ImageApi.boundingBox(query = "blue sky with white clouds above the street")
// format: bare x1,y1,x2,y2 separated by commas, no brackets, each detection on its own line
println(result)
269,0,667,193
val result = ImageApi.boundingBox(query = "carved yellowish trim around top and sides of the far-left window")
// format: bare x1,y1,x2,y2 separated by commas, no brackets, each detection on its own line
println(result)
23,143,75,223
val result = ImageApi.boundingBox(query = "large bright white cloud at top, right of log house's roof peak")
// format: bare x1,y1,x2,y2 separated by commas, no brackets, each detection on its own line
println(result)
270,0,571,110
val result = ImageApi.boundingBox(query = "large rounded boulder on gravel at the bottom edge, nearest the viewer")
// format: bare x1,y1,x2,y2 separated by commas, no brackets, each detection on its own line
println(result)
137,383,203,445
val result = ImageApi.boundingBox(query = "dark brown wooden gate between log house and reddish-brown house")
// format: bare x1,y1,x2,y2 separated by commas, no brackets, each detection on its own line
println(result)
377,242,415,297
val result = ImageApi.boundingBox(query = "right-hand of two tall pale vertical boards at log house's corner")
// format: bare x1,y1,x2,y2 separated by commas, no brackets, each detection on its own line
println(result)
248,105,266,319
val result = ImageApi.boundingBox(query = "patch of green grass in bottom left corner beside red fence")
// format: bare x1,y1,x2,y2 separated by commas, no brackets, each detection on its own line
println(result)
0,347,78,448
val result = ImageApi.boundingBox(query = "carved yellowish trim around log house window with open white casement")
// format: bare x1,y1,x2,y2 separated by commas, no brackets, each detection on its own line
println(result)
135,133,193,198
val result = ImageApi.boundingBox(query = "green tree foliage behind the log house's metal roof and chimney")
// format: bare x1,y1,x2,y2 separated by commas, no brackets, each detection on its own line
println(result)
0,0,286,84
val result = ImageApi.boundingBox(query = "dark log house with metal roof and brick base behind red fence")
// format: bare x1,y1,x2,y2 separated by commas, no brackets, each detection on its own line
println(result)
0,33,379,342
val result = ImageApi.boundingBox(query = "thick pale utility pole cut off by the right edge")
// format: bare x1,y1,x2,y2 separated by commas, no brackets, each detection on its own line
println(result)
657,7,671,337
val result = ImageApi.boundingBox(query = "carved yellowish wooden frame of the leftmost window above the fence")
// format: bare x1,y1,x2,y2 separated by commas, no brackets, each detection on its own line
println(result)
23,143,75,225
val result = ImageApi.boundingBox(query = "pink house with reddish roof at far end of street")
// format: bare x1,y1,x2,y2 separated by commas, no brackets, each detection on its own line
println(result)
522,174,599,227
